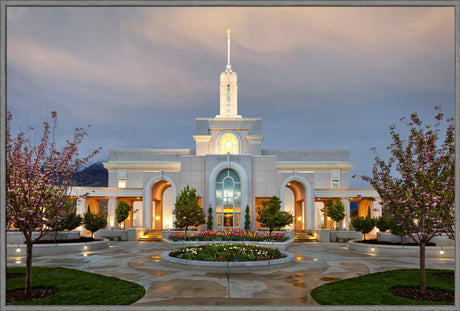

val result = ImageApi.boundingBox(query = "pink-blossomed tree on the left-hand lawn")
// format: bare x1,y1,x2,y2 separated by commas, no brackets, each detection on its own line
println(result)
6,112,100,296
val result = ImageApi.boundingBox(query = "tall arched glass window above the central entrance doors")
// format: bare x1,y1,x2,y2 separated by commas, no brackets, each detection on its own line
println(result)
216,169,241,229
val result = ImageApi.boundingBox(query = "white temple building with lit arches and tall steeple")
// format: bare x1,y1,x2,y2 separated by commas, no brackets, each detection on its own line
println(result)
73,30,380,238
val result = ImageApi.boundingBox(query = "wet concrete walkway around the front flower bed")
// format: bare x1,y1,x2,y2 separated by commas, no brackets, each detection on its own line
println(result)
7,242,455,305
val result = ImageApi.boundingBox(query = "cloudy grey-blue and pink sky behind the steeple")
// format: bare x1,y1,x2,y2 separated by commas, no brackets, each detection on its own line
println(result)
7,7,455,187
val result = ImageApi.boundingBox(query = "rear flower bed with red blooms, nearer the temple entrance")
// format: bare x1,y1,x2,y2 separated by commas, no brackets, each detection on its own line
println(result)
169,230,289,242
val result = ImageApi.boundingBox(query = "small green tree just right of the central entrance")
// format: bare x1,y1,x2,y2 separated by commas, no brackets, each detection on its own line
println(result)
256,196,294,238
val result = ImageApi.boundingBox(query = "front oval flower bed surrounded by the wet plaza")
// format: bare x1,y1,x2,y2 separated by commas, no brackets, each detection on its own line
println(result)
169,244,286,262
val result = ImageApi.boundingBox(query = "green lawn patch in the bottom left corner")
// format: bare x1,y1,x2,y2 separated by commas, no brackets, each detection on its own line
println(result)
6,267,145,305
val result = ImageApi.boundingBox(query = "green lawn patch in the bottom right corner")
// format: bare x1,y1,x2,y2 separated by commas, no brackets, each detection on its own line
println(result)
311,269,455,305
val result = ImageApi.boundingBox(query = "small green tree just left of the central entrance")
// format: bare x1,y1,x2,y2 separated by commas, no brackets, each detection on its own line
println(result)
173,186,205,236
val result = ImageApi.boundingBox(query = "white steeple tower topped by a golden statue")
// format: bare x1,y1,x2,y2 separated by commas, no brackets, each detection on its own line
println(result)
216,28,241,119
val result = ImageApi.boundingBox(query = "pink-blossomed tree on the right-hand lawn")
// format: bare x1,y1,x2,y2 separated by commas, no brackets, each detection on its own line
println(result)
362,106,455,294
